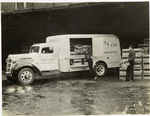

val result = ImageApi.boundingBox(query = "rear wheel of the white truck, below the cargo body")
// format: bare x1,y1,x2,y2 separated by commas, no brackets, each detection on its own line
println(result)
94,62,107,77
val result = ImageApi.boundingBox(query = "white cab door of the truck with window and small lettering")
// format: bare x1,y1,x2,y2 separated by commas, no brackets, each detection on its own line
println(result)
40,46,58,71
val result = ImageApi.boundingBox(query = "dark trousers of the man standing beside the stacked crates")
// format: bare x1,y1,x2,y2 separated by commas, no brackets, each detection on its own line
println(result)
126,62,134,81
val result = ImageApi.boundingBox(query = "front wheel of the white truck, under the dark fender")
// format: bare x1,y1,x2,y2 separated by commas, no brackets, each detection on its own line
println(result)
18,68,35,85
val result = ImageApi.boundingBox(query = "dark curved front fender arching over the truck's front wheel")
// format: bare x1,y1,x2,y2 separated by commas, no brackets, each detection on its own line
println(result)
12,62,41,76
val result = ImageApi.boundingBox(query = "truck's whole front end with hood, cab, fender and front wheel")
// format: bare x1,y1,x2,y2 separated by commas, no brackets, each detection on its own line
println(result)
6,43,58,85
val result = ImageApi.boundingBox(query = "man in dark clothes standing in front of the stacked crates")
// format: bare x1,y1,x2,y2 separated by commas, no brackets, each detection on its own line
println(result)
126,45,135,82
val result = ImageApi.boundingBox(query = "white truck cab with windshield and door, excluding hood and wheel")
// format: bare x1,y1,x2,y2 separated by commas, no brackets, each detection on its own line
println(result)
29,43,58,72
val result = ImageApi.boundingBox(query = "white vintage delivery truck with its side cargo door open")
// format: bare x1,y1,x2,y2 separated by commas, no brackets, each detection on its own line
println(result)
6,34,121,85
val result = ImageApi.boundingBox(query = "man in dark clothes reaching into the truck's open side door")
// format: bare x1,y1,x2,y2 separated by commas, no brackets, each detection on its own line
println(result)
84,48,97,80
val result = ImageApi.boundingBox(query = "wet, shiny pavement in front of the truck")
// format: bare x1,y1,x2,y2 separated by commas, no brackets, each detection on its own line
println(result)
2,75,150,116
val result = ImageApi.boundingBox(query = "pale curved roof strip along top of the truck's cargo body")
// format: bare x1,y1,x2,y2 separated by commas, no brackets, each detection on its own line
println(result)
47,34,117,38
